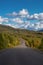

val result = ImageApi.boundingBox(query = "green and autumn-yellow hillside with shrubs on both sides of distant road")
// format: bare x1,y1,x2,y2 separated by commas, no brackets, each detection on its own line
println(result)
0,25,43,50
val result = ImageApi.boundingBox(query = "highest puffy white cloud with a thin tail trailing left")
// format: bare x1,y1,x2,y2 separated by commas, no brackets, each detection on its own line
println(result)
7,9,29,17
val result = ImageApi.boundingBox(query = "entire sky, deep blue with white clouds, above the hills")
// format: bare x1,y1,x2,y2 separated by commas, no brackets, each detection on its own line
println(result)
0,0,43,29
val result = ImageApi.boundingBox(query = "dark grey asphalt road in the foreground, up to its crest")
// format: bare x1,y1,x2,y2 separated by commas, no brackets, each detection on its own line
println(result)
0,48,43,65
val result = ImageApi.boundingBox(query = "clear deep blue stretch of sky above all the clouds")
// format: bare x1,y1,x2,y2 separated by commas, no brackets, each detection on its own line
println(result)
0,0,43,15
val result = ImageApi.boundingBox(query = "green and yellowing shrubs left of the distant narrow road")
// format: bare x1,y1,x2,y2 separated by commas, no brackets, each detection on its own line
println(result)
0,33,19,49
